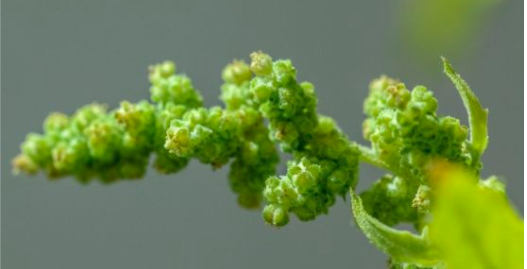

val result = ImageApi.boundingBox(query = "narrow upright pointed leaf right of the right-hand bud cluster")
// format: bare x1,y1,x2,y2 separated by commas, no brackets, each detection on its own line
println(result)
441,57,488,156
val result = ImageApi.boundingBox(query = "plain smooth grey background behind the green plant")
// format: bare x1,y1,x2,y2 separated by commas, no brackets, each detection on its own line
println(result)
1,0,523,269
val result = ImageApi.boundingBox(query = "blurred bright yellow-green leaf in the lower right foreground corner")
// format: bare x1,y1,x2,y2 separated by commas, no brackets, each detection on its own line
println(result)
430,171,524,269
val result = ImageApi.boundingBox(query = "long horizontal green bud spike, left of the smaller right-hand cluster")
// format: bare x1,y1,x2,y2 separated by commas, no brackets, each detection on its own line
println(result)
13,52,359,226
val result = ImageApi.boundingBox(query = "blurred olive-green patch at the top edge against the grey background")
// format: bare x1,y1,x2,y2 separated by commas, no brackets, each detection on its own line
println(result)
397,0,505,61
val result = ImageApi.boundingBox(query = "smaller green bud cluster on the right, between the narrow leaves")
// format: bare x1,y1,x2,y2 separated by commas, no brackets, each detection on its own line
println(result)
361,72,481,225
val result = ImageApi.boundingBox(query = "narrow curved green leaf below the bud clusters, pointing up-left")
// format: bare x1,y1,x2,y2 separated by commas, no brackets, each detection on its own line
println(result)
350,190,440,266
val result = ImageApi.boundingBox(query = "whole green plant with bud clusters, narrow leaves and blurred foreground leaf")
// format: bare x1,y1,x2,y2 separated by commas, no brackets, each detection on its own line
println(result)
13,52,523,268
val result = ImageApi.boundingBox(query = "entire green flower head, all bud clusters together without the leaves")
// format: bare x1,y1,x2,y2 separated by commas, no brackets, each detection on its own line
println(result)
13,52,483,231
